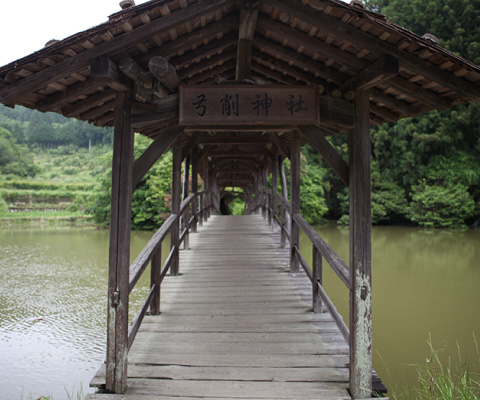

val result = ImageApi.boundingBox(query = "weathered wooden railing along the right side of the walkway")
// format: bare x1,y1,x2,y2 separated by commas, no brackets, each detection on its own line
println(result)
255,189,350,344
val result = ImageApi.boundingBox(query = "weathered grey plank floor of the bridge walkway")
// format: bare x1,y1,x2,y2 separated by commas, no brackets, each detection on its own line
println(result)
87,216,350,400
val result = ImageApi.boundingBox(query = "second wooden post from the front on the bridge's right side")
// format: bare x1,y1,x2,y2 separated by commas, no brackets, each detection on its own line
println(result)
290,131,300,272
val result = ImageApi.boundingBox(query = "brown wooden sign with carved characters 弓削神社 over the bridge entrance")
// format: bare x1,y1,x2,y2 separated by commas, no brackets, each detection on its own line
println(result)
179,85,318,126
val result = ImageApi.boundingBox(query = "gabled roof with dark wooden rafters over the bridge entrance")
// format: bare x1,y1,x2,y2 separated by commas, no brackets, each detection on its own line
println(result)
0,0,480,191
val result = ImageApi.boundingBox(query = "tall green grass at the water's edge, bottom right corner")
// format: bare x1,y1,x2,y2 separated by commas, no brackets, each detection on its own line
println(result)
392,335,480,400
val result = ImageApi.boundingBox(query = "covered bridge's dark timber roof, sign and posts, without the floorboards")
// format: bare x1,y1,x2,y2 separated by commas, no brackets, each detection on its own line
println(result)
0,0,480,399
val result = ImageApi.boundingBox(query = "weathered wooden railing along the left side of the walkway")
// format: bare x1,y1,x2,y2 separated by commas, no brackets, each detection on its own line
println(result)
128,192,211,349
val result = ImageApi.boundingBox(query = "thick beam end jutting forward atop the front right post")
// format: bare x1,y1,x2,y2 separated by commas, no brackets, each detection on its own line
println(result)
340,54,399,91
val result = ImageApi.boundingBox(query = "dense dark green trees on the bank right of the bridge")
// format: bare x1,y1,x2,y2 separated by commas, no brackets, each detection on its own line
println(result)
327,0,480,227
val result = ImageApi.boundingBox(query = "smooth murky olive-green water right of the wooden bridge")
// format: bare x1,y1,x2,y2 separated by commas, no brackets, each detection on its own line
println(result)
301,226,480,394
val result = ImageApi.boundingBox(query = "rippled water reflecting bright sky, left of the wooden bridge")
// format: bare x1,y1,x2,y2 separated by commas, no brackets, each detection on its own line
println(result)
0,229,151,399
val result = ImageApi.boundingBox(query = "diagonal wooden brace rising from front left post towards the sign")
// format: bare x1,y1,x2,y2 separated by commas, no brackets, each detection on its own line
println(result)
133,124,183,187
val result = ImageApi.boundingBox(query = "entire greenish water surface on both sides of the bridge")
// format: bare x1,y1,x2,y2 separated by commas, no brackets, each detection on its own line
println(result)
0,226,480,400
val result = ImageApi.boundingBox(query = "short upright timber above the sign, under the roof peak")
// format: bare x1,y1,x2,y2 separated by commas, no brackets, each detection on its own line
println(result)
235,0,260,81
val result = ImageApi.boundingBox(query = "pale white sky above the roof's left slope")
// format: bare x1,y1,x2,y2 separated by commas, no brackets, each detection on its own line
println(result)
0,0,147,66
